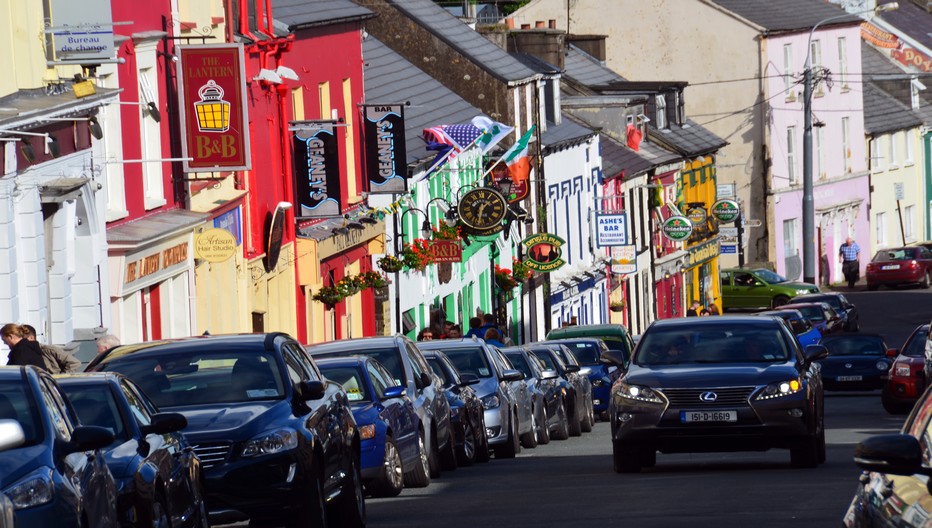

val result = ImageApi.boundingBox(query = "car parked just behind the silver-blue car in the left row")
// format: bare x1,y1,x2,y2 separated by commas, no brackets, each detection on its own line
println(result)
501,346,567,444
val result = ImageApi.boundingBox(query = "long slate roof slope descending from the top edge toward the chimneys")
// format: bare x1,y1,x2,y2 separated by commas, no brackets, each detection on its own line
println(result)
386,0,537,83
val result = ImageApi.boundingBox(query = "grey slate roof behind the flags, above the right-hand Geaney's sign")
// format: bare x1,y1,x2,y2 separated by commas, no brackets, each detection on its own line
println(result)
362,35,483,164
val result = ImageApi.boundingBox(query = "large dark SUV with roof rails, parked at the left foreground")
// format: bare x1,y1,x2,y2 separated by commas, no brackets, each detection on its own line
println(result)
88,333,366,526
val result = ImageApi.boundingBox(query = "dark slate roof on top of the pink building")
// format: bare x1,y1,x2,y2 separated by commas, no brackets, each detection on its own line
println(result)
708,0,860,33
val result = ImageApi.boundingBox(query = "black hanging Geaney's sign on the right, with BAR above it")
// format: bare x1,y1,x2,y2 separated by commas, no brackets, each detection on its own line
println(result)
363,104,408,194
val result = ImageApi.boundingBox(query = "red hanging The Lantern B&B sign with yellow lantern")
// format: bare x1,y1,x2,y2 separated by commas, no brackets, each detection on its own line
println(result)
177,44,252,172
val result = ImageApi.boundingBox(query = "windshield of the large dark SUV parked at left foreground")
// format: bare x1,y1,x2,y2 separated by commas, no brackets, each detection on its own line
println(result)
102,349,285,408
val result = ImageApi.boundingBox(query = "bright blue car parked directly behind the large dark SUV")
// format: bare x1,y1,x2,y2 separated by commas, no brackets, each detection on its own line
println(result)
317,356,430,497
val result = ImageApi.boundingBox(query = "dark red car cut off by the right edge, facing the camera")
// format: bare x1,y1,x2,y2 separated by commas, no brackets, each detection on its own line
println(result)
881,324,929,414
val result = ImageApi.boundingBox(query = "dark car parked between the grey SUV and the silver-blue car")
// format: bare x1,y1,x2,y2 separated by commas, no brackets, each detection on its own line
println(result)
424,350,491,466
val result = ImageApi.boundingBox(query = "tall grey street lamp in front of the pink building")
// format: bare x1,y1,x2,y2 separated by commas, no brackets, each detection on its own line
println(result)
803,2,900,284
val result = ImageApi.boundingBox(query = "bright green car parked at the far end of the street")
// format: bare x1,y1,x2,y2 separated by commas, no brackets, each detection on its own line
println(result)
721,268,819,310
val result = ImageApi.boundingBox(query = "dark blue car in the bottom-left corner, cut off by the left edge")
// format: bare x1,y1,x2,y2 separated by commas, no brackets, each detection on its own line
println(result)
0,367,120,528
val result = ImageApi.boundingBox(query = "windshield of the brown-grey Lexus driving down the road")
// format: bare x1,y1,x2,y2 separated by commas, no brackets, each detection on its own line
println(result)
634,324,792,367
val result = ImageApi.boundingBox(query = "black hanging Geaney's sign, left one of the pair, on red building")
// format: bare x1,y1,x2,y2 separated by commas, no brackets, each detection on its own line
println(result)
292,121,341,219
